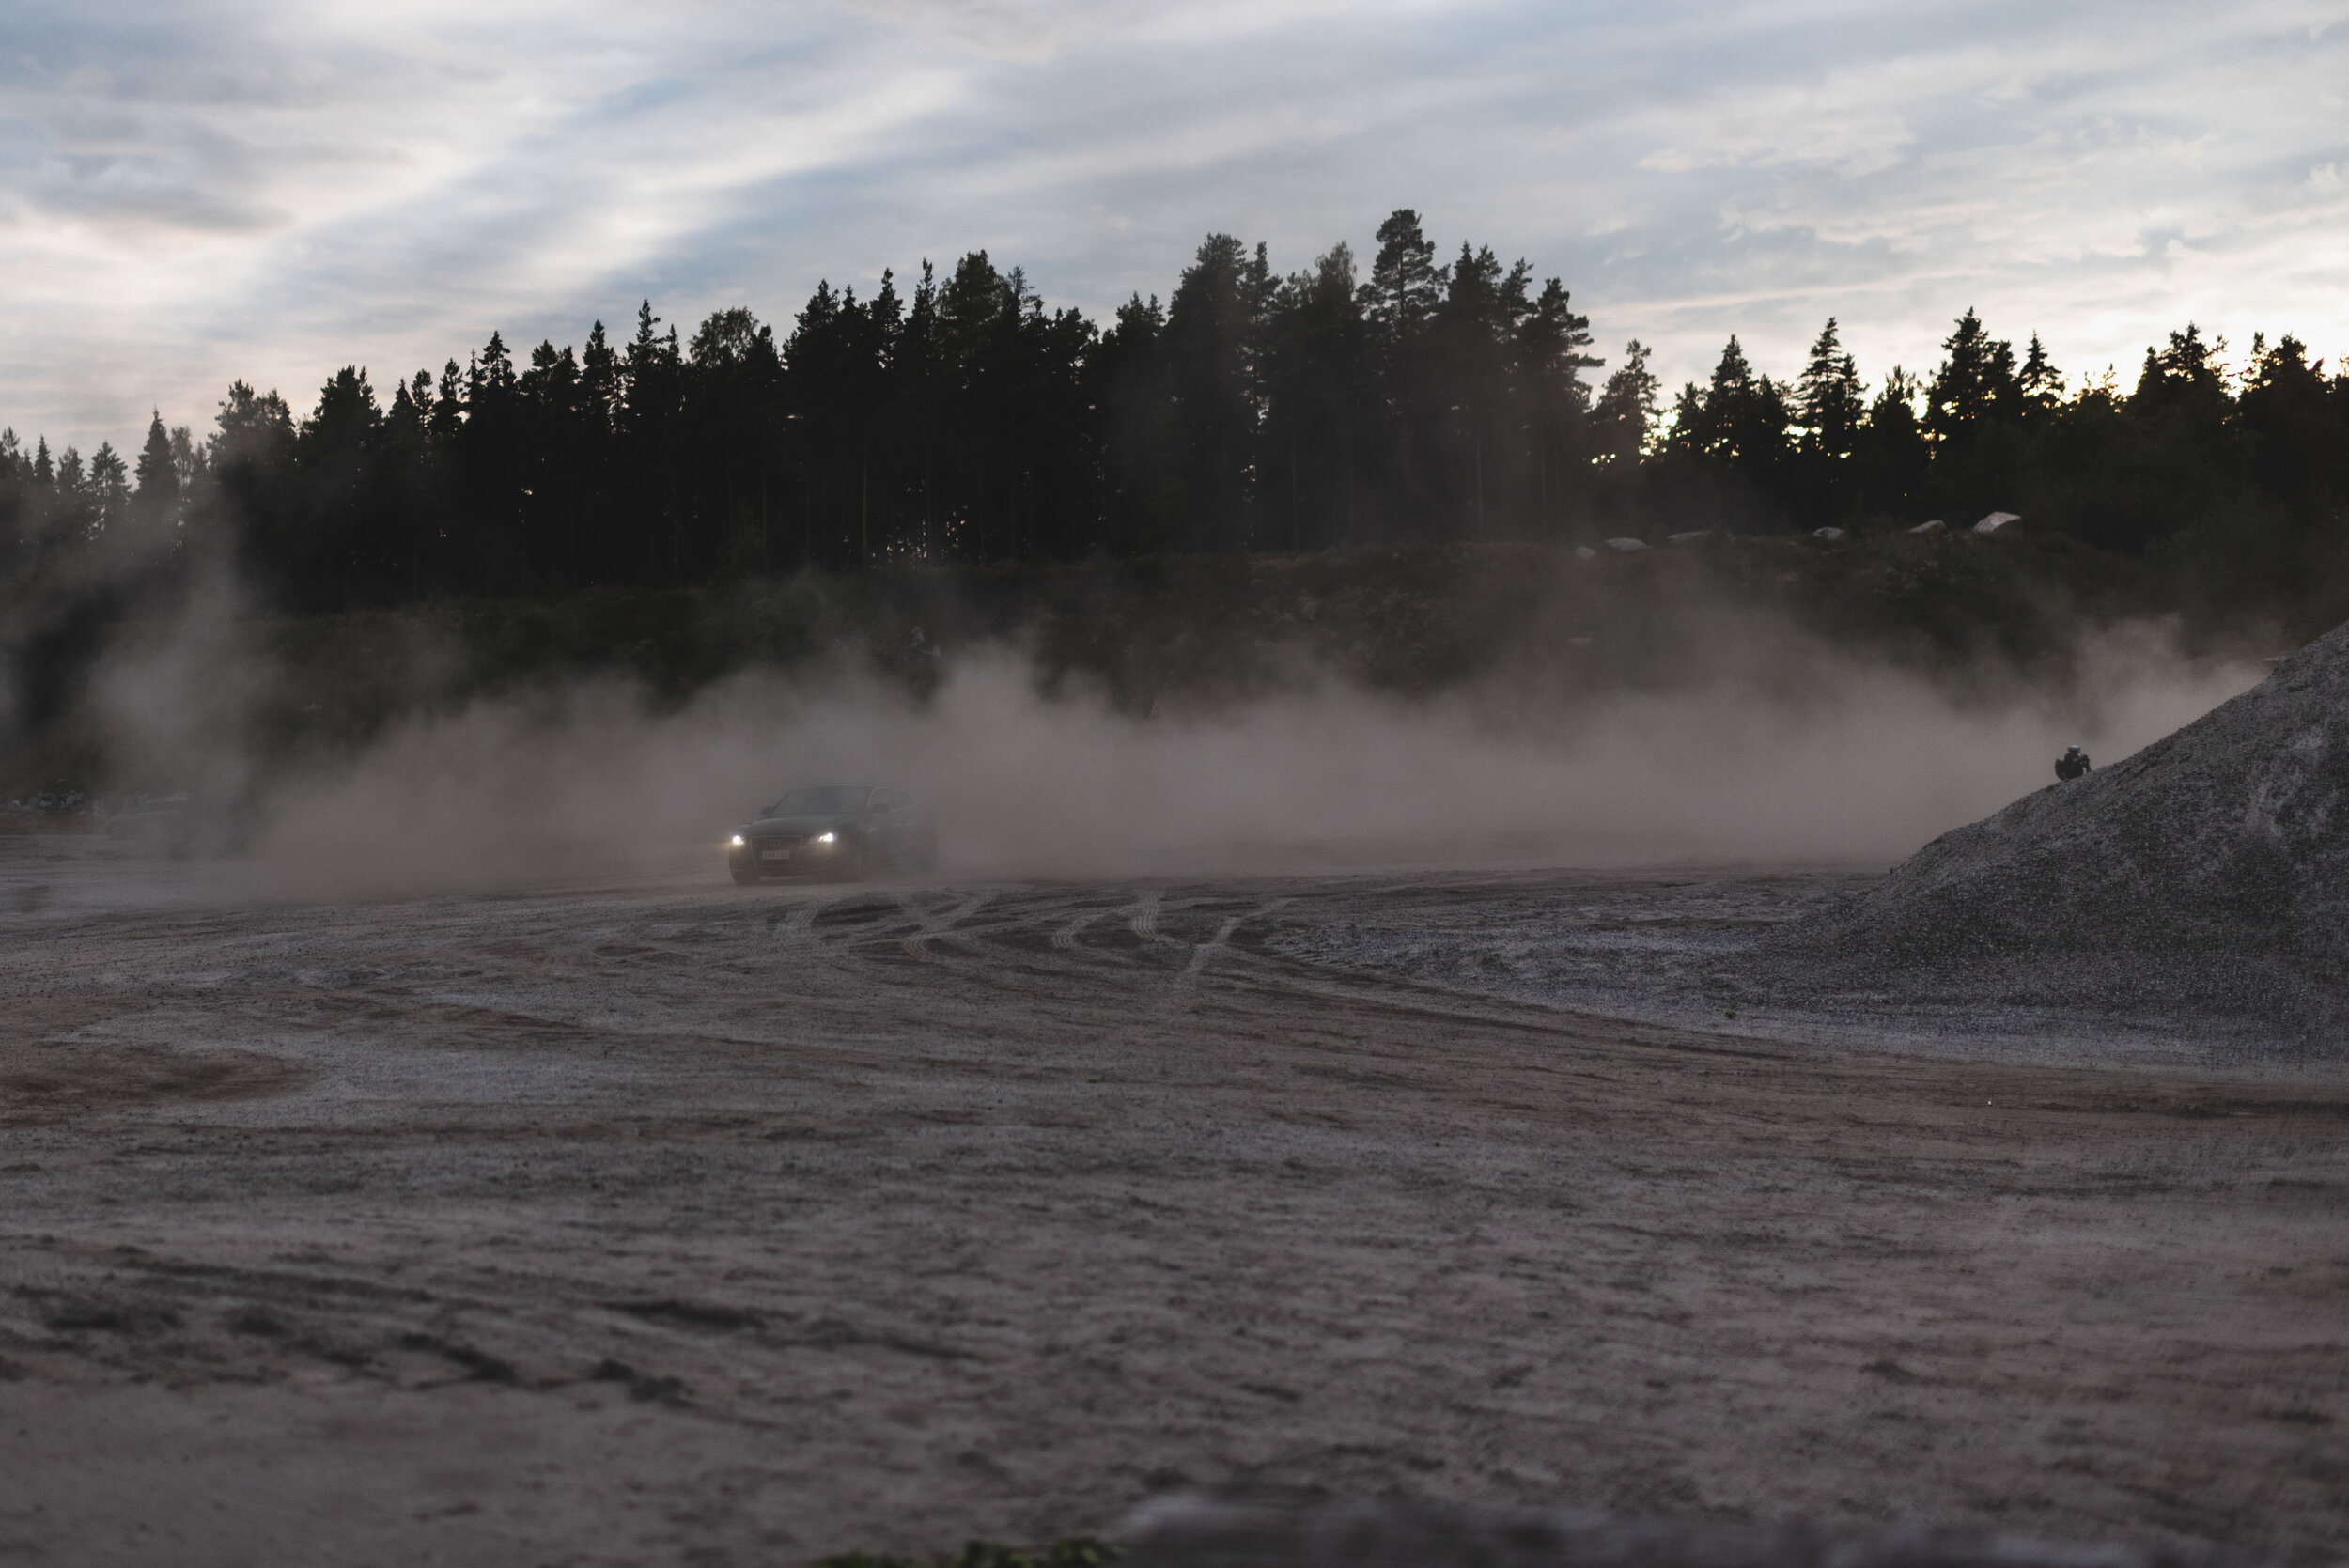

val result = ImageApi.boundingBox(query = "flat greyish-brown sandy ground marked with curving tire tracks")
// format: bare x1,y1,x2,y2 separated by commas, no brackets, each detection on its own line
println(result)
0,838,2349,1566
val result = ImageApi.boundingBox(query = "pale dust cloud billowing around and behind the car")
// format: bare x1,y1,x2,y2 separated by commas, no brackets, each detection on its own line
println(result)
73,594,2264,899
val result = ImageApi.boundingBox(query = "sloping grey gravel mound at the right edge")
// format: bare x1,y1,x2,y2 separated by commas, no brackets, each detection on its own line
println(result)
1752,625,2349,1059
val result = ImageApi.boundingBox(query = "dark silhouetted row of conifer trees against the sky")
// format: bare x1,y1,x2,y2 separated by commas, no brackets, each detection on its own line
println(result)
0,211,2349,611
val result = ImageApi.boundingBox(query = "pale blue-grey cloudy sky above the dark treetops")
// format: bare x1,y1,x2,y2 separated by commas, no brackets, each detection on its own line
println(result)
0,0,2349,451
